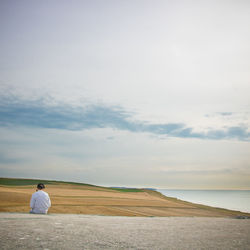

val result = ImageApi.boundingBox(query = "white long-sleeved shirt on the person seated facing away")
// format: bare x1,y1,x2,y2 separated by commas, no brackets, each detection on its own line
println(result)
30,190,51,214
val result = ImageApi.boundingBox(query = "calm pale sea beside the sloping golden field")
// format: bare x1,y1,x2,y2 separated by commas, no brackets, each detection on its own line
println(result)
157,189,250,213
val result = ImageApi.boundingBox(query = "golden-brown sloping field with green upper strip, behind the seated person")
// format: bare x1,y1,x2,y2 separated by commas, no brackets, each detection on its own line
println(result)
0,178,250,217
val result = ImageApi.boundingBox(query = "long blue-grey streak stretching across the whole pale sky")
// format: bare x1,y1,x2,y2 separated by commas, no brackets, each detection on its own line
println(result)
0,98,250,141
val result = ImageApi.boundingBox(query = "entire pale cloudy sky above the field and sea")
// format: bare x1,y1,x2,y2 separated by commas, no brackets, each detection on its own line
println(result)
0,0,250,189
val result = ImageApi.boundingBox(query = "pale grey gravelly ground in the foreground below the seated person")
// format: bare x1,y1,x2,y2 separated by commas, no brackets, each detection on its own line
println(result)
0,213,250,250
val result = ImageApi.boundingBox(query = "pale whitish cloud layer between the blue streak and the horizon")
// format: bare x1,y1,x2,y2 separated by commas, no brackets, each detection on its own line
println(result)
0,128,250,188
